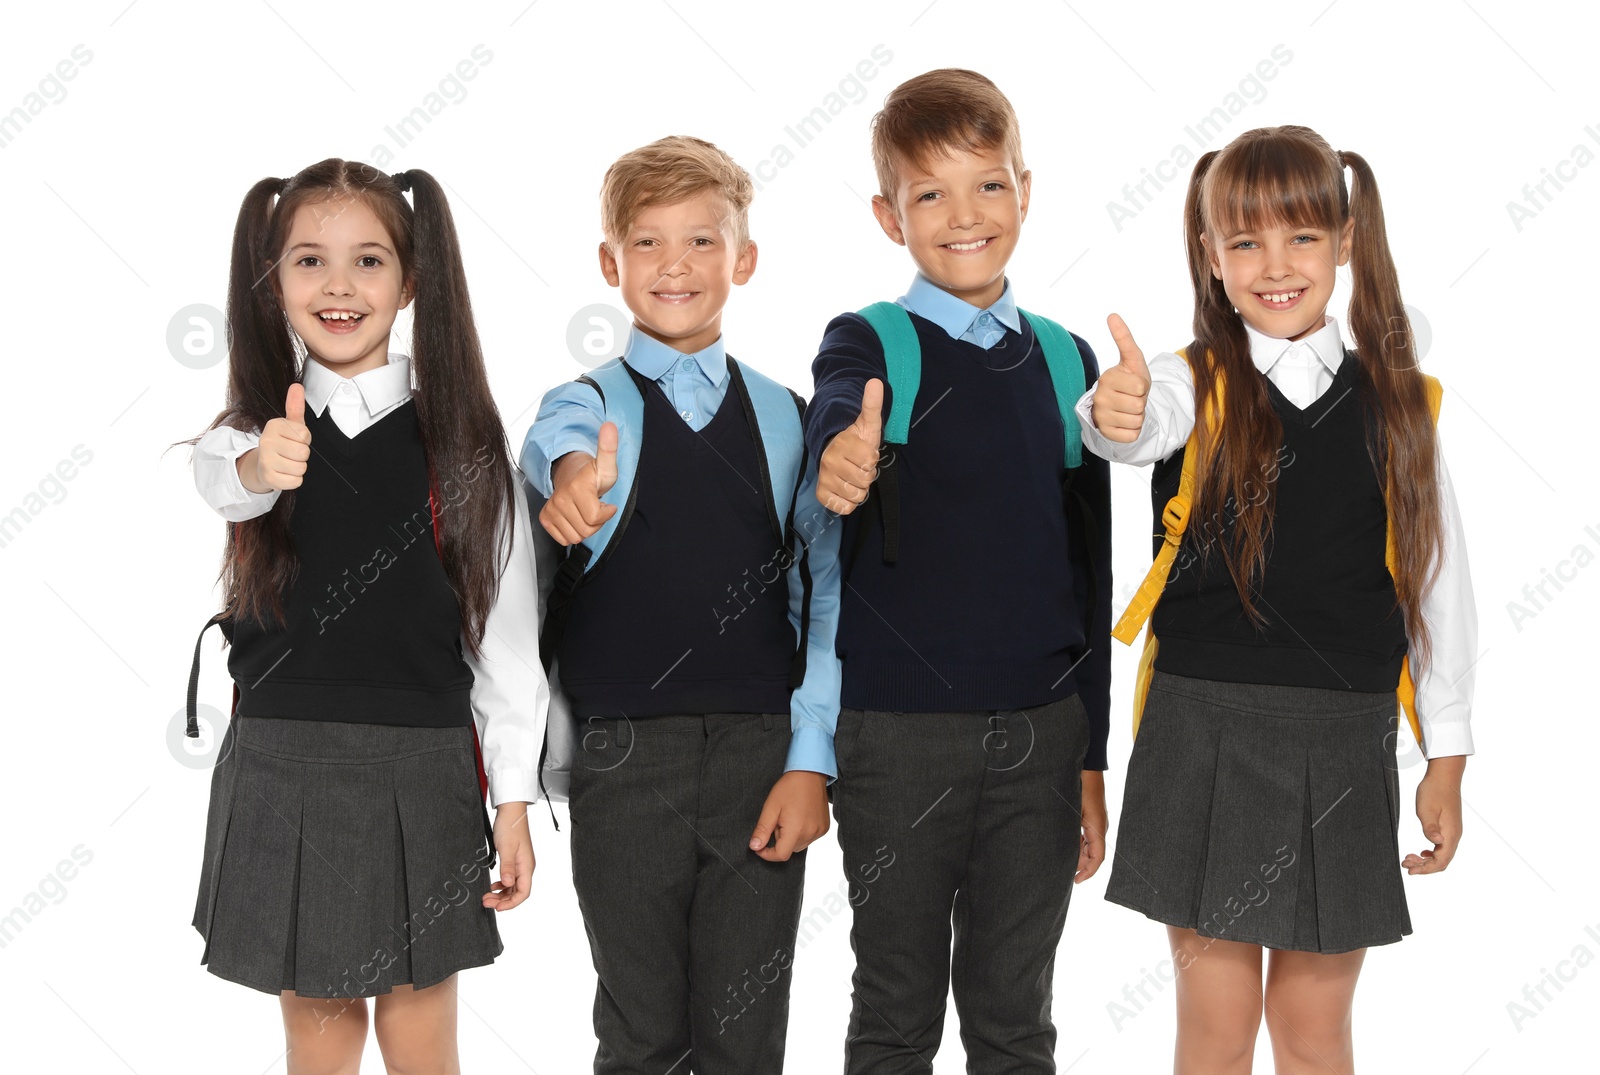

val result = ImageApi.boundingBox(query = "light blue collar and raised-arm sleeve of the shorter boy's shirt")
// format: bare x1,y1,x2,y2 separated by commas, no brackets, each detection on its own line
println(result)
523,328,728,496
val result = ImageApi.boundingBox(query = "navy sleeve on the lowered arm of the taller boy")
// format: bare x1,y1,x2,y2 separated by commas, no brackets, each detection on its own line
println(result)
1067,333,1113,769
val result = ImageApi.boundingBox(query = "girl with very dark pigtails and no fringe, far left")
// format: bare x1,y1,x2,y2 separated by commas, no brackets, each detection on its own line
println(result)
189,160,547,1073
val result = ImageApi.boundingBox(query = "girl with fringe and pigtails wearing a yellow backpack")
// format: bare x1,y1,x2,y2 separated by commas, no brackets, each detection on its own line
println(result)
1078,126,1478,1075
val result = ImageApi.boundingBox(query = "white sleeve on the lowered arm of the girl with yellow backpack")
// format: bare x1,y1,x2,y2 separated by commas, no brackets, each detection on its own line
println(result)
1416,435,1482,758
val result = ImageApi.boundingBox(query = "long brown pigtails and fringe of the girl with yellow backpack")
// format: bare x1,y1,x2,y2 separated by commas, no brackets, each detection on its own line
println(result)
1184,126,1443,662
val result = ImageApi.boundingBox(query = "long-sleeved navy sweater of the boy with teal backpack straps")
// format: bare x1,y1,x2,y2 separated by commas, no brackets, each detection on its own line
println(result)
805,314,1110,769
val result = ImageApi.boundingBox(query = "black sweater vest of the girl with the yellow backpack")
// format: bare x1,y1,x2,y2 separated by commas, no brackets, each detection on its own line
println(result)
1150,354,1406,693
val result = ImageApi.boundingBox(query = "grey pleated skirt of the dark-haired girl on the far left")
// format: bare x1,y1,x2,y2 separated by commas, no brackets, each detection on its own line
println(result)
194,717,501,998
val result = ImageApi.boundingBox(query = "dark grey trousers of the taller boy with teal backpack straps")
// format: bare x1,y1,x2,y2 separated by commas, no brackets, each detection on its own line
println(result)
834,696,1088,1075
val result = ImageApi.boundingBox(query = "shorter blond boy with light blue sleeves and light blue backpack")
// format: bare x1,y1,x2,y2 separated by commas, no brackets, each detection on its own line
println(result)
522,138,838,1075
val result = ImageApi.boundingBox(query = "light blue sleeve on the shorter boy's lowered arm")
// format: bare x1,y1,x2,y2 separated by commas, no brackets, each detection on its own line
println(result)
784,447,854,782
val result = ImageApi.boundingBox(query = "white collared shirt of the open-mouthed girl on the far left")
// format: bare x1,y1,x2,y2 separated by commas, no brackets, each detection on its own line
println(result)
194,354,550,806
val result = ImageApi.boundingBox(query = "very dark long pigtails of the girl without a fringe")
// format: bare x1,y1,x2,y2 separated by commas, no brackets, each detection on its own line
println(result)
211,158,514,654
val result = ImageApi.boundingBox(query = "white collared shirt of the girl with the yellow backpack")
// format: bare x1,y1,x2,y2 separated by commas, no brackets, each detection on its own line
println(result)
1077,317,1482,758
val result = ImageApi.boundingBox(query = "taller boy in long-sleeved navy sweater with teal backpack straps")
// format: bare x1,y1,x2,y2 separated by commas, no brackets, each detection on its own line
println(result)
806,70,1110,1073
